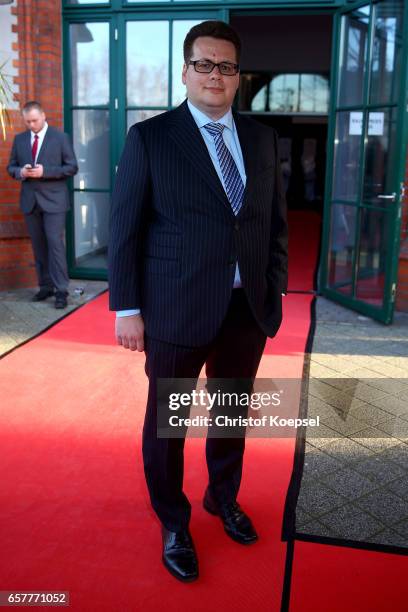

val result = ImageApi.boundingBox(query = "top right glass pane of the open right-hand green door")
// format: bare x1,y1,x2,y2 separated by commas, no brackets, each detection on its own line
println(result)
370,0,404,104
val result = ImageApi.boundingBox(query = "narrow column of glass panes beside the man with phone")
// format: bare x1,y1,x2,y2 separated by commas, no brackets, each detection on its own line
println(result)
65,17,114,278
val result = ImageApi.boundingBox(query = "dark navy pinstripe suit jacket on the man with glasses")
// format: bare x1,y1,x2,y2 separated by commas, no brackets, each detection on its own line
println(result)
109,102,287,346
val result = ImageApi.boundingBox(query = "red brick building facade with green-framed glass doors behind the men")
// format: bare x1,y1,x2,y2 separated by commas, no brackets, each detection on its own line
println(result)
0,0,408,323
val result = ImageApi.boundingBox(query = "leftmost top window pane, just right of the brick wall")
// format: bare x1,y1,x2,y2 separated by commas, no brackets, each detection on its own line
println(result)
70,23,109,106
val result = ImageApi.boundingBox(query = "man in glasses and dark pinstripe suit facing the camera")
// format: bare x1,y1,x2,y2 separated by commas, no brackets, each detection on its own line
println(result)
109,21,287,581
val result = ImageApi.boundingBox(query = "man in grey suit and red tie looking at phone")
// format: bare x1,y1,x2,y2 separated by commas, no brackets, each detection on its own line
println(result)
7,101,78,308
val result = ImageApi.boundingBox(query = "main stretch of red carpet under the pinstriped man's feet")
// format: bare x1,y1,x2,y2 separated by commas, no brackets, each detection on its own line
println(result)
0,295,311,612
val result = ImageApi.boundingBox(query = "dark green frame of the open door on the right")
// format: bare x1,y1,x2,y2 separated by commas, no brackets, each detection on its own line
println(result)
319,0,408,324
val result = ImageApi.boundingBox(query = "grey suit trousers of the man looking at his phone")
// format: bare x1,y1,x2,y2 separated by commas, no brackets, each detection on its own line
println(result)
24,204,69,293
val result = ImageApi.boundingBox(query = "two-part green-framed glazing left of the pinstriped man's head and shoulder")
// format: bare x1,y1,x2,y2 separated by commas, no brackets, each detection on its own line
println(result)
64,9,225,279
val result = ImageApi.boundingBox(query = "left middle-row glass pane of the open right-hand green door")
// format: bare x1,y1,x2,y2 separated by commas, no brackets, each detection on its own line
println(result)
333,112,363,201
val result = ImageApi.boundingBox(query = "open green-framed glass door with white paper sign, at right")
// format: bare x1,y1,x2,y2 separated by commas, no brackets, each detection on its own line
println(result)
321,0,407,323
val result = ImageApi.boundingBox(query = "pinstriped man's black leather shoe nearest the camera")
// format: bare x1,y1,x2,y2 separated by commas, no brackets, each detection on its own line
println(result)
162,527,198,582
